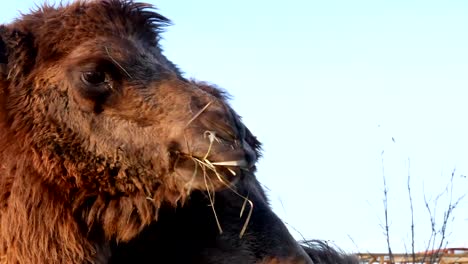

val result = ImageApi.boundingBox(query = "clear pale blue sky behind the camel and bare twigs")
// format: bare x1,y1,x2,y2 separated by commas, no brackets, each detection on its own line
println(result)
0,0,468,252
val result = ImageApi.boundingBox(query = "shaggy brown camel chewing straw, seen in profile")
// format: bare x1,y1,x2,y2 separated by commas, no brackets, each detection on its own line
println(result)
0,0,358,264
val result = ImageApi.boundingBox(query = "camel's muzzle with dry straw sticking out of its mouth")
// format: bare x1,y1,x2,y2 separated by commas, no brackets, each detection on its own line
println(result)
169,116,257,191
